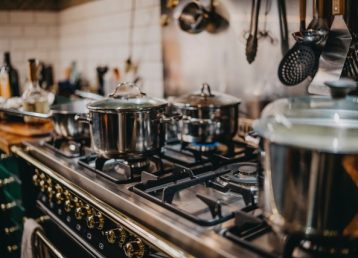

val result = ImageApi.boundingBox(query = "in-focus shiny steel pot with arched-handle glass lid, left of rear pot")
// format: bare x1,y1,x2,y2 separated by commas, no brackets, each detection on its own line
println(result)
78,83,167,159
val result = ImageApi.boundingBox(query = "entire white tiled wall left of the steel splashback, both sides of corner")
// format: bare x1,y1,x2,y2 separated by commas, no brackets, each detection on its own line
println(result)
0,0,163,96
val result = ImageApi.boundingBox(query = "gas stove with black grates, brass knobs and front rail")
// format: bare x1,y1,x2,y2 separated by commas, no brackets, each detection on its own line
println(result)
13,137,356,258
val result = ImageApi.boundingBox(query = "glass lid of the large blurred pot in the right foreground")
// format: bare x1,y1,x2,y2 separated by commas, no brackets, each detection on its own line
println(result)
253,80,358,153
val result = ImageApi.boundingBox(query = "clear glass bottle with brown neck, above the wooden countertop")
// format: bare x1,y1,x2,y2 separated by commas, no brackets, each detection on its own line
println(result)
22,59,49,123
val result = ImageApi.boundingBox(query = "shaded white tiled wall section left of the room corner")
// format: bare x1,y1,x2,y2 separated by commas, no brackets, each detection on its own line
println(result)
0,11,58,89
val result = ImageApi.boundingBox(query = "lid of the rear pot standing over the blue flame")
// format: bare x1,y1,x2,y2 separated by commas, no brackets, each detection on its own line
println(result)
174,83,241,108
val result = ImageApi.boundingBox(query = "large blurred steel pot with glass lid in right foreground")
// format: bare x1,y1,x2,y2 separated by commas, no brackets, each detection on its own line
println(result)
254,81,358,248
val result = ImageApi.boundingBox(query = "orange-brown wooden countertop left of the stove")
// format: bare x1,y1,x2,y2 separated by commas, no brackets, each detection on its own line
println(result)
0,121,53,154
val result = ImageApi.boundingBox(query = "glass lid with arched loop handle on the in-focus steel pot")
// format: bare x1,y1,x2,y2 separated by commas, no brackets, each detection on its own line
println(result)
87,82,167,111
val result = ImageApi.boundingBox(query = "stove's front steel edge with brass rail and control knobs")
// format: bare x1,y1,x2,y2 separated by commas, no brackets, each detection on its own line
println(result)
12,143,263,258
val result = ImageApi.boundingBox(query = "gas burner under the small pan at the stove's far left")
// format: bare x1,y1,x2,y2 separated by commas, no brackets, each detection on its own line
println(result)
44,138,90,158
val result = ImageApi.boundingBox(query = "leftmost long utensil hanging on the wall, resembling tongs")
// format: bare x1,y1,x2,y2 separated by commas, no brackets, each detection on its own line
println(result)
246,0,261,64
